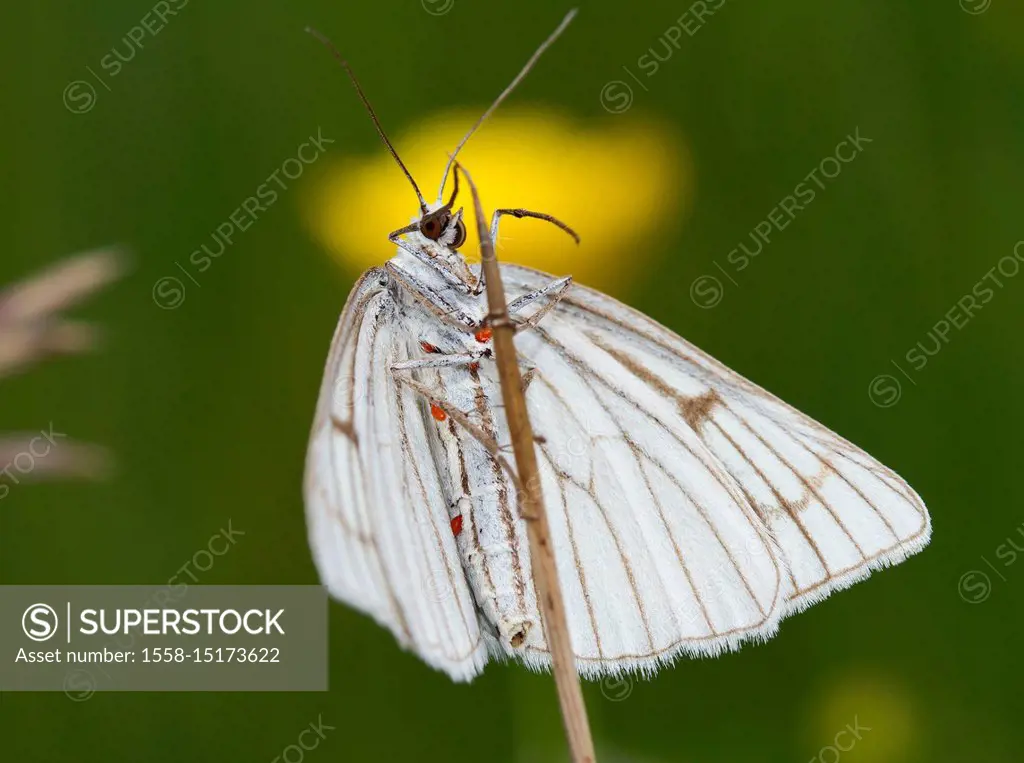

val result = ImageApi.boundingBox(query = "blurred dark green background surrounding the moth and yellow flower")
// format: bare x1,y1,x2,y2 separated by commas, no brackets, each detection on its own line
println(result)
0,0,1024,763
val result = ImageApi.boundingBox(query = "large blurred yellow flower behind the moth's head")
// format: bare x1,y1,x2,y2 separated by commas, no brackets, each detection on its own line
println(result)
303,109,692,288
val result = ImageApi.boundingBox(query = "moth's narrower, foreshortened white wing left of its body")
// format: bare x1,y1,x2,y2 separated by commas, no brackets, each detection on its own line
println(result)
305,269,486,680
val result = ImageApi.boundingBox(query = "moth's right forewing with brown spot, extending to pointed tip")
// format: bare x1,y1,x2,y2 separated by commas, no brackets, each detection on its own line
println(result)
506,267,931,630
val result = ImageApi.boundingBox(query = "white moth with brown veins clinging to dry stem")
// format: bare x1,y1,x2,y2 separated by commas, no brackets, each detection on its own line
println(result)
305,14,931,680
